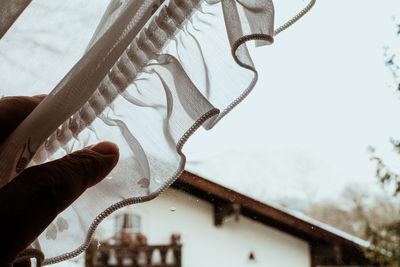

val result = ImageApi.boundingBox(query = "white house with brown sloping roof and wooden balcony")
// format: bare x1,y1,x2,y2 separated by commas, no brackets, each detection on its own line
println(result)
86,172,369,267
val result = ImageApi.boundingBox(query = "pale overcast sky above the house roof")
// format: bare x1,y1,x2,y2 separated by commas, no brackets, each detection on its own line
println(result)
186,0,400,202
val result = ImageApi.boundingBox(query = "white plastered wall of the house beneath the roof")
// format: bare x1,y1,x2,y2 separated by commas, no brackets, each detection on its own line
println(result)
114,189,311,267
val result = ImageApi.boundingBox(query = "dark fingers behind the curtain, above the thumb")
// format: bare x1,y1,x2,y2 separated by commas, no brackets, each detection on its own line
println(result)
0,95,46,142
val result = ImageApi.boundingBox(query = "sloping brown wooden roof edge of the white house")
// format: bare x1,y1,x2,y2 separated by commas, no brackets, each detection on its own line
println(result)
172,171,368,266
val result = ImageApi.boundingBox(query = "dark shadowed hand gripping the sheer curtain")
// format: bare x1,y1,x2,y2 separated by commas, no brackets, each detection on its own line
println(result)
0,95,119,266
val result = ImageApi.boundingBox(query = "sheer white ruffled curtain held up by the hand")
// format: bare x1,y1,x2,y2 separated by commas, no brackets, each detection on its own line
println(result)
0,0,313,264
